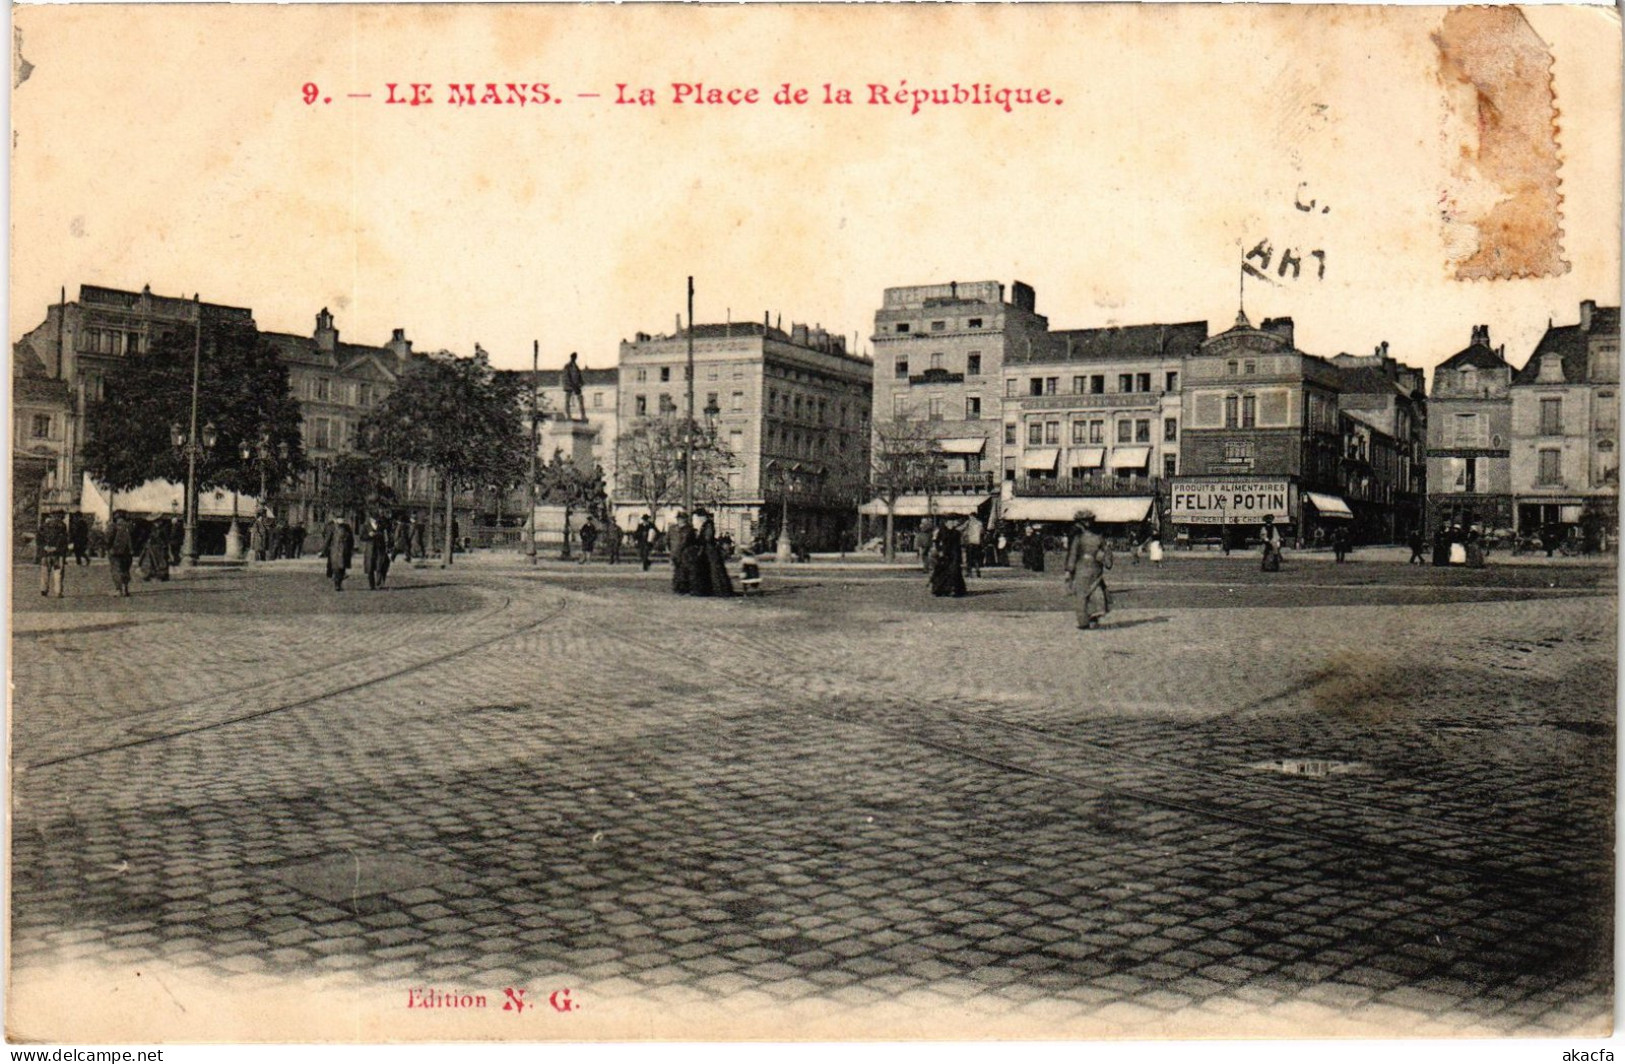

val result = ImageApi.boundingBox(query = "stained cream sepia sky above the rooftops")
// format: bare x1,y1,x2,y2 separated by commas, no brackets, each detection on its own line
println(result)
11,5,1620,376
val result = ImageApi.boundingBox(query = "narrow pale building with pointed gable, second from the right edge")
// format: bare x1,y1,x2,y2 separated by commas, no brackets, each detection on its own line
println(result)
1427,325,1513,534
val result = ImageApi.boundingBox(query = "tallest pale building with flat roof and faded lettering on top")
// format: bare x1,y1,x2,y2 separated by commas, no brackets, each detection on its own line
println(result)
863,281,1048,518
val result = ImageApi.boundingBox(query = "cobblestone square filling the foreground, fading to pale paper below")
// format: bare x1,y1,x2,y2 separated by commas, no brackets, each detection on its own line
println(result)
11,556,1617,1041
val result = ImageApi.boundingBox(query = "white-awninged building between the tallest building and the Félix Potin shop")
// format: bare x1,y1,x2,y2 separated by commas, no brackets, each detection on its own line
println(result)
1001,322,1207,525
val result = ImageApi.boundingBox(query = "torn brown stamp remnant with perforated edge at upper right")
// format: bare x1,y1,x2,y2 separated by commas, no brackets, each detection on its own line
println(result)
1433,8,1568,281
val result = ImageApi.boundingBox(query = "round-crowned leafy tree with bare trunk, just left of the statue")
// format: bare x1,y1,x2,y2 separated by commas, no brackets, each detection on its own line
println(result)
361,346,528,565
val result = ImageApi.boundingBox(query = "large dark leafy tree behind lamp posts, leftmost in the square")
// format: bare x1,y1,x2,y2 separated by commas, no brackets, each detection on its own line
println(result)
85,316,306,492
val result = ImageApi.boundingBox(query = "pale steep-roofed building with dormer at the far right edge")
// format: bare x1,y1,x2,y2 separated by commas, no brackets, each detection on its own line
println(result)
1511,299,1620,544
